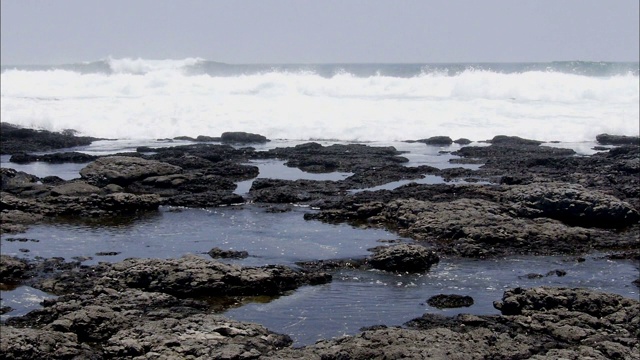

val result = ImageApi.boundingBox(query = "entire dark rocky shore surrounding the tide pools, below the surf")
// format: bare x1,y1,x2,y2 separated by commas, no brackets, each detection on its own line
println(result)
0,123,640,359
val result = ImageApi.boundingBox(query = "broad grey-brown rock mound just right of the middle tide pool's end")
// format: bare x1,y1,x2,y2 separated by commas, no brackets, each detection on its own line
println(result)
375,199,597,255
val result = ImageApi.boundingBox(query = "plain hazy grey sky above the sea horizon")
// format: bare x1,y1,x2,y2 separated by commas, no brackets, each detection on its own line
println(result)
0,0,640,65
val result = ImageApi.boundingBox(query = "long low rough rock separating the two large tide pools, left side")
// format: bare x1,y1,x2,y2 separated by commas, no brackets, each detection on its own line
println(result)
33,255,331,297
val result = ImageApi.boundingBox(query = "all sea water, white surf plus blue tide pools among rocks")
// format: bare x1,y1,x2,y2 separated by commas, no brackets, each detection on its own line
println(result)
0,59,639,345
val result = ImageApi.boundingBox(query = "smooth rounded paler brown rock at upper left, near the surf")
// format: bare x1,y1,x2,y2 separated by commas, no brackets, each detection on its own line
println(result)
80,156,182,186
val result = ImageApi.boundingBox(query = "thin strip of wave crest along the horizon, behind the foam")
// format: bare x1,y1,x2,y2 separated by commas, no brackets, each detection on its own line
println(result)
2,57,640,78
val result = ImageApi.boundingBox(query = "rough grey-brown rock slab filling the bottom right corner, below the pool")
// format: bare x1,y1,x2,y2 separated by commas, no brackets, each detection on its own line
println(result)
272,288,640,360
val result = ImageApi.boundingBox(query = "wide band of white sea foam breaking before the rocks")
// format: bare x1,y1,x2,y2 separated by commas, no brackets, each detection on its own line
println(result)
1,59,640,141
